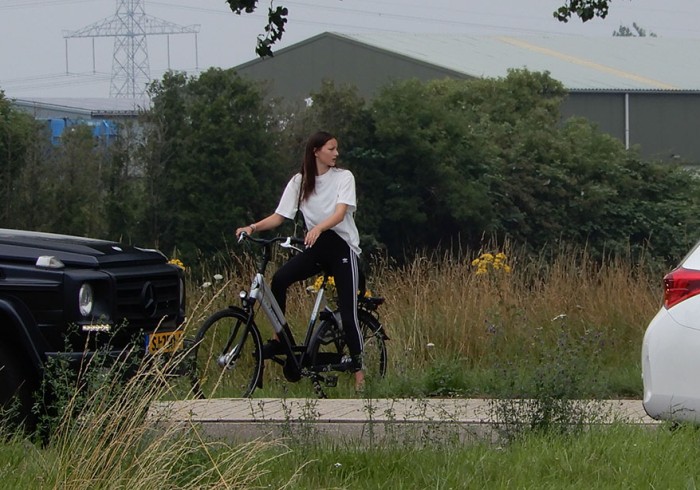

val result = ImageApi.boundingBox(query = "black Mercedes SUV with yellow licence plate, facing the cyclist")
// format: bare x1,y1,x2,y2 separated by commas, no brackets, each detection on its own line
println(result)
0,229,185,422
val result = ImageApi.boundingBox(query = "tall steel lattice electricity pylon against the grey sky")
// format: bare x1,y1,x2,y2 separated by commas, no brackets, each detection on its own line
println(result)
63,0,200,98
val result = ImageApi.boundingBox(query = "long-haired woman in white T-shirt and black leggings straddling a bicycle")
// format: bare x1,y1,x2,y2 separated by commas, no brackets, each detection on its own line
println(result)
236,131,364,390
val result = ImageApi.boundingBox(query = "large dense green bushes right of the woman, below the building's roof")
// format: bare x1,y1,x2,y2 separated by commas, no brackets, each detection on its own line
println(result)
304,70,700,262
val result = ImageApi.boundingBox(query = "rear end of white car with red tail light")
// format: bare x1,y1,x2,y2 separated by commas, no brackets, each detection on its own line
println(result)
642,242,700,422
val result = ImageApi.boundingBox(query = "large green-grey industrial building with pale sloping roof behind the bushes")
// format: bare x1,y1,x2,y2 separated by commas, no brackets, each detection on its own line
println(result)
236,32,700,165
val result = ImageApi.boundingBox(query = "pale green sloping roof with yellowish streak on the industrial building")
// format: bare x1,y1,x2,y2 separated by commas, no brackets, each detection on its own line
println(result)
332,32,700,91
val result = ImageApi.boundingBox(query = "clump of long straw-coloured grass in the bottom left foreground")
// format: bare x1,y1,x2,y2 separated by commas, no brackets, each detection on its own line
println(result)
19,346,285,490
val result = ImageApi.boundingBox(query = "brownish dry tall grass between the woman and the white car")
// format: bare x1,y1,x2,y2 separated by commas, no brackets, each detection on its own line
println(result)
373,245,660,368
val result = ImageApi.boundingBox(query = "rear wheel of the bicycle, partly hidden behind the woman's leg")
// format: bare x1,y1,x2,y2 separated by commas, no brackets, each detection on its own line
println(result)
312,310,388,378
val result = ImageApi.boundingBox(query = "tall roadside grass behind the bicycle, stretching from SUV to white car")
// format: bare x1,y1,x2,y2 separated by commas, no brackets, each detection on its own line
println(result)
183,241,661,396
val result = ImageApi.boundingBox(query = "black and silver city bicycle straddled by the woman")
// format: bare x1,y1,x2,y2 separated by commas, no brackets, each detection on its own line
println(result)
192,233,389,398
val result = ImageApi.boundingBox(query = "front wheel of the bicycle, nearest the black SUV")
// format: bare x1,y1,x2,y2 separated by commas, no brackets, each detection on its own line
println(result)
192,307,263,398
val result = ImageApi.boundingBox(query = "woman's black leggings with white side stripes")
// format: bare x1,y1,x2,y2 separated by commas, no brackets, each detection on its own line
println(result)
270,230,363,369
